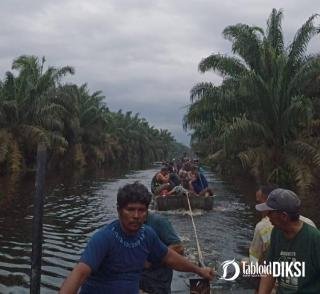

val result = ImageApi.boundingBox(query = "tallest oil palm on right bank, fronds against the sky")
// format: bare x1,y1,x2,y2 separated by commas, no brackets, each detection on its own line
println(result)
185,9,320,191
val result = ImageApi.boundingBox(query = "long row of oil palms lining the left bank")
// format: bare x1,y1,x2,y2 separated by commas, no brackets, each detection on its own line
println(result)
0,56,185,175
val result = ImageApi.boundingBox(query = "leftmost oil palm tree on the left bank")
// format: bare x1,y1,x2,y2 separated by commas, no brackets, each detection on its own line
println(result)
0,56,74,170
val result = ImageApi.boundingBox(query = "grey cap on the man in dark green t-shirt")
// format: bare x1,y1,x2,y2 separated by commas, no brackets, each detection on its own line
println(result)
256,188,301,213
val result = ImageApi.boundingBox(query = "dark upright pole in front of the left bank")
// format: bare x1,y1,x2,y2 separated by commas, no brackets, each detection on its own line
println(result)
30,143,47,294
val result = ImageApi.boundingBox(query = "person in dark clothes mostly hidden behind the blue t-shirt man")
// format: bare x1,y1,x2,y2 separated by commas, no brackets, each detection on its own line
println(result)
140,212,184,294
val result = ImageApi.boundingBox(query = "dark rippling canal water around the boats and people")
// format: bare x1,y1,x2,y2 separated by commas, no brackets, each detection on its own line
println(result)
0,166,320,294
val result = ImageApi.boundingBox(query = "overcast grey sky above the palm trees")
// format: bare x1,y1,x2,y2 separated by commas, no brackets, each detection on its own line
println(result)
0,0,320,143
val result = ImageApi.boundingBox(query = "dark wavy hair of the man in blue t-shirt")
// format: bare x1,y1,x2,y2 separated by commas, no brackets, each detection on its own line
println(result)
117,182,151,209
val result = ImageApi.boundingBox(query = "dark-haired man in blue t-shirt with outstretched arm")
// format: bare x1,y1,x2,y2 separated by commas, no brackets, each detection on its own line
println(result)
60,182,214,294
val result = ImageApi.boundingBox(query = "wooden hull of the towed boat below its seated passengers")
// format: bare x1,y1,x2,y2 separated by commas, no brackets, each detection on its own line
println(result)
154,193,214,211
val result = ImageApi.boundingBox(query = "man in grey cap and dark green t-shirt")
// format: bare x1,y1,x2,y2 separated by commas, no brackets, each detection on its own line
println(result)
256,189,320,294
